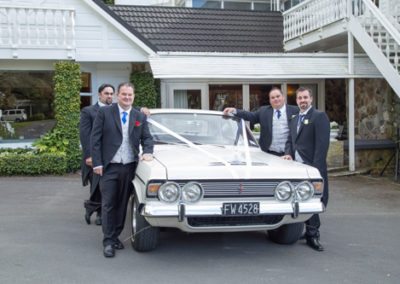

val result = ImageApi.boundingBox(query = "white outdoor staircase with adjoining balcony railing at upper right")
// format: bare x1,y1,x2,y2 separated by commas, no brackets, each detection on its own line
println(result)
283,0,400,97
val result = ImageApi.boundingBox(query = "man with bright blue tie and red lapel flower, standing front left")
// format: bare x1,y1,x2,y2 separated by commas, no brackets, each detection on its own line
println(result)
91,83,154,257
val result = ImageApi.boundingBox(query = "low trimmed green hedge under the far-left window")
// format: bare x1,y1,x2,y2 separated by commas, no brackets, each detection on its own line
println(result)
0,149,67,176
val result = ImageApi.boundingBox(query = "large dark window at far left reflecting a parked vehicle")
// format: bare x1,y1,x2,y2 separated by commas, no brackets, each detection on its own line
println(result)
0,71,55,140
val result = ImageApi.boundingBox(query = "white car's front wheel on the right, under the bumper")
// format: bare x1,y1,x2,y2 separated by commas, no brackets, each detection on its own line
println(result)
268,223,304,245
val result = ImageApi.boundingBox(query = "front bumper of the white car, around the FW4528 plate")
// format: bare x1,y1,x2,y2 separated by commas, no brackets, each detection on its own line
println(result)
141,198,325,232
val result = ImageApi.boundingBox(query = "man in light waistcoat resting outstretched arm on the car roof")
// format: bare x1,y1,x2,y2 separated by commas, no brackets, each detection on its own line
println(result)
224,87,299,156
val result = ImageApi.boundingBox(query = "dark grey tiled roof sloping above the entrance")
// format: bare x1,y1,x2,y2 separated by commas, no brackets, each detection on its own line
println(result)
94,0,283,53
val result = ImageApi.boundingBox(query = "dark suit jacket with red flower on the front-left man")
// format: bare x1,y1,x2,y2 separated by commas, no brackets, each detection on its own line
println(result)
91,103,154,170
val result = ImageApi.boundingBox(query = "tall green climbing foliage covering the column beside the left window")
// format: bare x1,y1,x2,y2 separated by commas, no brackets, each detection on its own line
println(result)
34,62,82,171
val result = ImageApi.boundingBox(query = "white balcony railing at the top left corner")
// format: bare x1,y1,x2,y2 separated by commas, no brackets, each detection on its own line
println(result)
0,5,75,49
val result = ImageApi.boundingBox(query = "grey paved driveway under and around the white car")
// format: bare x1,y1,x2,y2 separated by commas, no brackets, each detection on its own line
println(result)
0,175,400,283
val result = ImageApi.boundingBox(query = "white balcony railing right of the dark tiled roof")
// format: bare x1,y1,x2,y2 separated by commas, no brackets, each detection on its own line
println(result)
283,0,347,41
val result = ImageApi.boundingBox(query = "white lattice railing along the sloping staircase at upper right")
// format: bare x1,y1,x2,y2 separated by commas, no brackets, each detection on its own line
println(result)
353,0,400,72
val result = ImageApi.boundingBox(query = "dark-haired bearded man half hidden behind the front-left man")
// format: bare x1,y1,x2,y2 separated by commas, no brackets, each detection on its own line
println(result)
79,84,115,225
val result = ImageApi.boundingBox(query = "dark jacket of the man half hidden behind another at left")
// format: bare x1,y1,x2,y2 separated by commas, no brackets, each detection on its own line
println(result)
79,103,100,187
